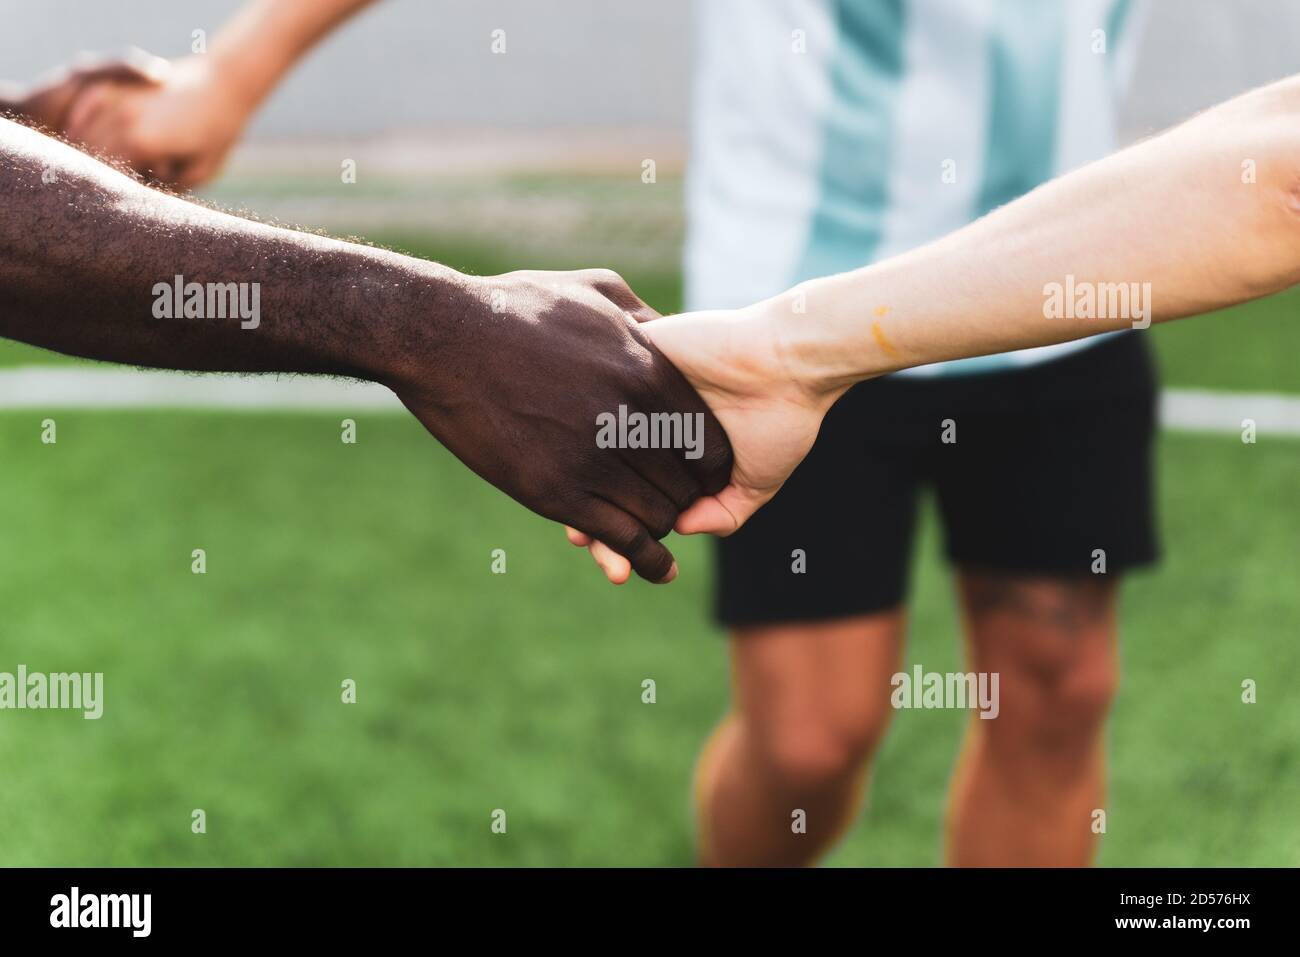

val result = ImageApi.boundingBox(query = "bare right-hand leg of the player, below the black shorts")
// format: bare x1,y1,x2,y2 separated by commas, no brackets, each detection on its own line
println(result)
948,570,1118,866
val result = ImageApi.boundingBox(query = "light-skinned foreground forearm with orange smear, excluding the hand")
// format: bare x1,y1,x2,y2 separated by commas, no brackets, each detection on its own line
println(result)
758,79,1300,393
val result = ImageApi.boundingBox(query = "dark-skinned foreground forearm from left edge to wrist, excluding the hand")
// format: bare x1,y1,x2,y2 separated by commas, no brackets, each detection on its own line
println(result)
0,121,472,381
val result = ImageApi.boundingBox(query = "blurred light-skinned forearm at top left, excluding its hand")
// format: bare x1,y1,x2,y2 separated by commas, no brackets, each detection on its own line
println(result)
208,0,376,112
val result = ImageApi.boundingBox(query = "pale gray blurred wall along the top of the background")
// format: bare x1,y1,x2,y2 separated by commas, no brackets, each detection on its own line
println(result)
0,0,1300,137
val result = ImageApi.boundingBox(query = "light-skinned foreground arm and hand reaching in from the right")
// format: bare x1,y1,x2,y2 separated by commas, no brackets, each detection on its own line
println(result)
569,70,1300,581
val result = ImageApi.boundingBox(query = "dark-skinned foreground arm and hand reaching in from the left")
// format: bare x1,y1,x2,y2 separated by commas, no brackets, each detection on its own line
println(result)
0,120,731,581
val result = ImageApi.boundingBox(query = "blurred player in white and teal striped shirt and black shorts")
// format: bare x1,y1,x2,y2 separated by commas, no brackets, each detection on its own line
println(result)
629,0,1157,866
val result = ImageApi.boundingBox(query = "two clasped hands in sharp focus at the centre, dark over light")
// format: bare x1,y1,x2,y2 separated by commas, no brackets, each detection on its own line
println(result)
378,269,840,584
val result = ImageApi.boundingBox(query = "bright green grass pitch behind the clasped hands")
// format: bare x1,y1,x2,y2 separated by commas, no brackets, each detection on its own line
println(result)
0,195,1300,866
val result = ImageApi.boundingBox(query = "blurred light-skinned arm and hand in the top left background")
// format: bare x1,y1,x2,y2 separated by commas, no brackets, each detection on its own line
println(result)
52,0,374,189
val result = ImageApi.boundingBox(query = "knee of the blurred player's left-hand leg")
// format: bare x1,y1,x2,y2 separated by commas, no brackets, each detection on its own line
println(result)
757,711,888,794
